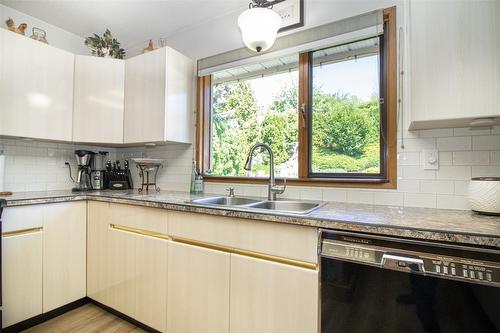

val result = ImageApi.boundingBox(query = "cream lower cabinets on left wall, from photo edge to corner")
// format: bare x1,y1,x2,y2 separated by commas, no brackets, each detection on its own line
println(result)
2,201,86,327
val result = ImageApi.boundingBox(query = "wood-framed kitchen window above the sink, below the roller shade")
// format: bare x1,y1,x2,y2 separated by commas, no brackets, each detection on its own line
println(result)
196,9,396,188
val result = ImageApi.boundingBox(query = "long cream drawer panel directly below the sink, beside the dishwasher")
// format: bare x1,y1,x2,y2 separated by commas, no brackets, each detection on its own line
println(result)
168,211,318,263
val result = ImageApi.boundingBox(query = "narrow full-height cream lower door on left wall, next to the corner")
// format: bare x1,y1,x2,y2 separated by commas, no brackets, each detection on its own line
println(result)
43,201,87,312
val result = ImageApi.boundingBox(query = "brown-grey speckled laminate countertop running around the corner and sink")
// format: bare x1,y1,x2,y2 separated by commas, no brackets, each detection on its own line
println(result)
0,190,500,249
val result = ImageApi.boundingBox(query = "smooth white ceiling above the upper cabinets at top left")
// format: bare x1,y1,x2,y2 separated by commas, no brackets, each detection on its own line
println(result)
0,0,250,49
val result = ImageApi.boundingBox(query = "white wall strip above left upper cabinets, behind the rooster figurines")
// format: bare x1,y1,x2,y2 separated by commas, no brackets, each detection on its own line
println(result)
0,4,90,54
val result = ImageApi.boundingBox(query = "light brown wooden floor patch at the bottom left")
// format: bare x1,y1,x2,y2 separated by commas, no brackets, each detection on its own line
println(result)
23,304,145,333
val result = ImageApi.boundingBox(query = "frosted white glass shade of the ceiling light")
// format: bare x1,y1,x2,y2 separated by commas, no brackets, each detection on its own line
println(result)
238,8,281,52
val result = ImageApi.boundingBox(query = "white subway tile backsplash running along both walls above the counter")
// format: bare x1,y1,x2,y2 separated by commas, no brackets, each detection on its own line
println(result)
0,126,500,210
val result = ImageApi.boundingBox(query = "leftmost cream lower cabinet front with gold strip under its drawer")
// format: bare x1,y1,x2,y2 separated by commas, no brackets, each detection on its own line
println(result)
2,206,43,328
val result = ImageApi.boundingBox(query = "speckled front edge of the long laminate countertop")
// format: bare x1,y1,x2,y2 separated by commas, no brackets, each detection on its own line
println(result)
0,194,500,248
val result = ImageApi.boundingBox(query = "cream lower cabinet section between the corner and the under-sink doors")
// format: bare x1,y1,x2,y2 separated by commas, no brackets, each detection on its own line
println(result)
87,202,168,332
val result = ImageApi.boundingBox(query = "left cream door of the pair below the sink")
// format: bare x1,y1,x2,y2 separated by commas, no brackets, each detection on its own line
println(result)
167,242,230,333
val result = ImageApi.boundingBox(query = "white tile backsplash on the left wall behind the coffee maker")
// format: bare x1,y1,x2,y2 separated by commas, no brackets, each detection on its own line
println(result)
0,138,116,192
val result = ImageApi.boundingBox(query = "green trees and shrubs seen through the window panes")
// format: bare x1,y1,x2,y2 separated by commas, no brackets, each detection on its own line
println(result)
212,78,380,176
